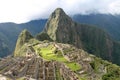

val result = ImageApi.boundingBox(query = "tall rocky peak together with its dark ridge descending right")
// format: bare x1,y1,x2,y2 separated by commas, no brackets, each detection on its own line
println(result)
44,8,114,61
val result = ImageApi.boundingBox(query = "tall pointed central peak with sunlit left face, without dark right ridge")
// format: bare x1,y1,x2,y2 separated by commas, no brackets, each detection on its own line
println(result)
44,8,82,47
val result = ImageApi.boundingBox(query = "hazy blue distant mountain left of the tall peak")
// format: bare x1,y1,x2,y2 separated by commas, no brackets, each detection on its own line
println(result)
0,19,47,57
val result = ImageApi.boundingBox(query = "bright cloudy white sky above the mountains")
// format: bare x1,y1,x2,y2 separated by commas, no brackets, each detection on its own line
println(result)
0,0,120,23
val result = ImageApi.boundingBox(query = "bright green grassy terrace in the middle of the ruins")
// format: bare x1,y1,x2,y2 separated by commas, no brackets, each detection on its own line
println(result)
34,45,80,71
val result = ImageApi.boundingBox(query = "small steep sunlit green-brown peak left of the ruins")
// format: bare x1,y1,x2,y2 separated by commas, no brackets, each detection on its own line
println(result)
14,29,35,56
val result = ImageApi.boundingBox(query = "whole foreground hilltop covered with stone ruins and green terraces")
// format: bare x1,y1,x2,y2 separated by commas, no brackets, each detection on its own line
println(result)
11,30,120,80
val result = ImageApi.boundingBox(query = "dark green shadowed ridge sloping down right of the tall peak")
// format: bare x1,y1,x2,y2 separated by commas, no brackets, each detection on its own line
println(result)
78,24,112,60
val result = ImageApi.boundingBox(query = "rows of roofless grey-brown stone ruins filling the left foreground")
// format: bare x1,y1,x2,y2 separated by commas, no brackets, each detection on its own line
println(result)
0,57,78,80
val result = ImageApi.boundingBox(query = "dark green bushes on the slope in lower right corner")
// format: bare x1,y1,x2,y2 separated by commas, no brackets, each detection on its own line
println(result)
90,57,120,80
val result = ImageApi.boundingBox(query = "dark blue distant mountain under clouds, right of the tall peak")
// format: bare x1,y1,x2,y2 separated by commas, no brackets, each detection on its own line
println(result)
72,14,120,41
